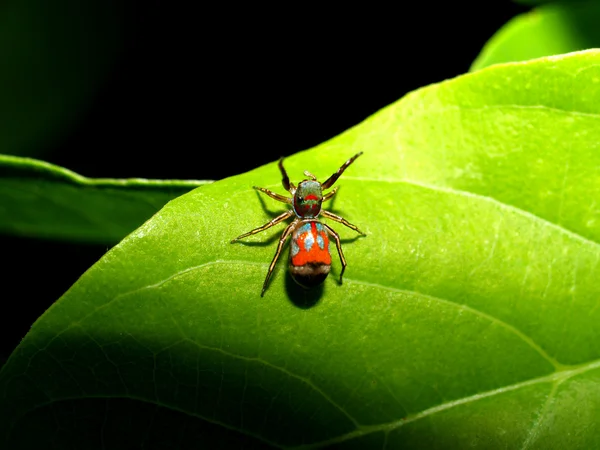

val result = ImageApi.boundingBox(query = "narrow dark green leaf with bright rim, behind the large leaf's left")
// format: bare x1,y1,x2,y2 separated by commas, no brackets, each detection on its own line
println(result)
0,155,209,245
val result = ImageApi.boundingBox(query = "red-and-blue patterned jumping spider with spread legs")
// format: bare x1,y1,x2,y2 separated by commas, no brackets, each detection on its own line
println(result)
231,152,365,297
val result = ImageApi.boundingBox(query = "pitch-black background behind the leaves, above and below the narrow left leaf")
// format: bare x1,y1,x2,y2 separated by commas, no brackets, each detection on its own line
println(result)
0,0,528,364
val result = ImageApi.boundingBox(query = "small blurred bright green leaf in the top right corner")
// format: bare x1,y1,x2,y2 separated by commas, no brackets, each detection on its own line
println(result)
470,1,600,71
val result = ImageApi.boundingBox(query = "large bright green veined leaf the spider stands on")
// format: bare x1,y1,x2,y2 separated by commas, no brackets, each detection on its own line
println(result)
0,51,600,449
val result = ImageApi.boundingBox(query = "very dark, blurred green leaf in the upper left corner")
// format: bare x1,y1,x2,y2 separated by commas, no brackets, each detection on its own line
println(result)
0,0,126,156
